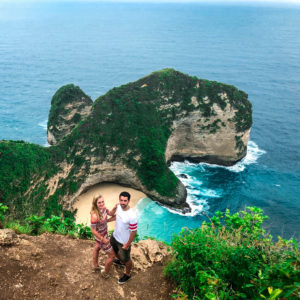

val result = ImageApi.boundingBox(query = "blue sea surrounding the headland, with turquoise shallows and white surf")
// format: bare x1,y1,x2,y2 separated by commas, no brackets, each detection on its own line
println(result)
0,1,300,241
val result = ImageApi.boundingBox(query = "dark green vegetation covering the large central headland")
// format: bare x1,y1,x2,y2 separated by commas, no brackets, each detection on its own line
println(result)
57,69,252,197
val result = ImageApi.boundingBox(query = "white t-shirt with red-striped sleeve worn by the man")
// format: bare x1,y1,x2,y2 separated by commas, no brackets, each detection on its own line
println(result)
113,205,137,244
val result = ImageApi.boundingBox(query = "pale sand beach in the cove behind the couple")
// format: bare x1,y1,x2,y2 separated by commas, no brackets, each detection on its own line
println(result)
73,183,146,230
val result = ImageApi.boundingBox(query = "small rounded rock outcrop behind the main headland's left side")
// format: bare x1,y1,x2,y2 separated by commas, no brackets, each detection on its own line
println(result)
47,84,93,145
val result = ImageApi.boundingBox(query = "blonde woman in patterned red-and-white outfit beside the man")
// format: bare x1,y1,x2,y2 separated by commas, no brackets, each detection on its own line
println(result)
91,195,117,278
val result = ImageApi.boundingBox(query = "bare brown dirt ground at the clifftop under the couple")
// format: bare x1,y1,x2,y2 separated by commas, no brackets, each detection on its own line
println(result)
0,234,173,300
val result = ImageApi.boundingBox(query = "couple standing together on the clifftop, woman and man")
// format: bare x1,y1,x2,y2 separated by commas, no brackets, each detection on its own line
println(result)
91,192,137,284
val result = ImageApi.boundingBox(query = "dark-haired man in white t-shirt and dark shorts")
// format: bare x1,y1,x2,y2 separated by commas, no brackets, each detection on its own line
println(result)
110,192,137,284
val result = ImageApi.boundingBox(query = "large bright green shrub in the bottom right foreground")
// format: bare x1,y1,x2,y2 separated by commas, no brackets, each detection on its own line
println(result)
165,207,300,299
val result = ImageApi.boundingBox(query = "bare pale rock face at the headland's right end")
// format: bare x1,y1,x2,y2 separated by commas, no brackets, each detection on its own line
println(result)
165,94,250,166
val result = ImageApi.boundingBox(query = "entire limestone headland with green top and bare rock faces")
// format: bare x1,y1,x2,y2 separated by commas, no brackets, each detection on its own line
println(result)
0,69,252,218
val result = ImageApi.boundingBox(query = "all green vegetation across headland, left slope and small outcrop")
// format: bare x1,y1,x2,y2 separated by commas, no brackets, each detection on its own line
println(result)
0,69,252,219
